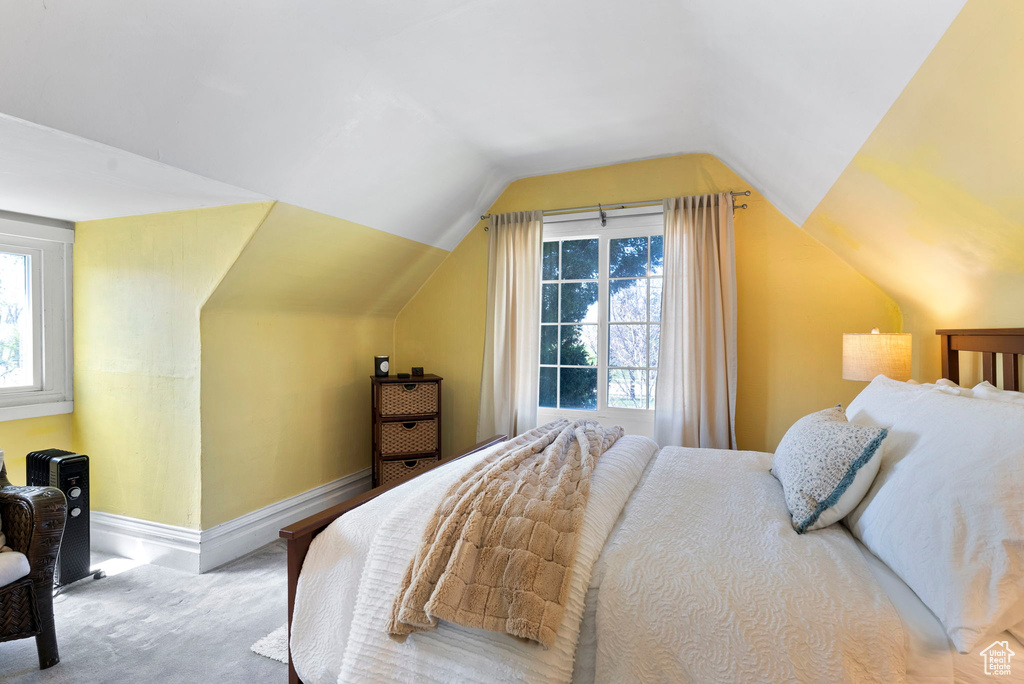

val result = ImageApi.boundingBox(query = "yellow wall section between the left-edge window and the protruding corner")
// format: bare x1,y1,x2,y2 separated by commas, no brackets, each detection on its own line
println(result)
72,203,271,527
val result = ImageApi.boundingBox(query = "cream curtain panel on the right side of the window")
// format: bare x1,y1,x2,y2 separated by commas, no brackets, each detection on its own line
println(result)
654,193,736,448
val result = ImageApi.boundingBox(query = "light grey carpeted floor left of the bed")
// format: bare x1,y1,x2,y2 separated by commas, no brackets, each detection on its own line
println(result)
0,542,288,684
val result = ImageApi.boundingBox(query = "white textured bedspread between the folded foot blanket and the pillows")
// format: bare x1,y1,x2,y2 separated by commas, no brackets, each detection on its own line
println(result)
577,447,906,682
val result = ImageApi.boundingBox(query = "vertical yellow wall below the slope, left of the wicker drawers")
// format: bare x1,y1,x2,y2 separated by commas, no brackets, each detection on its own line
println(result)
202,311,394,528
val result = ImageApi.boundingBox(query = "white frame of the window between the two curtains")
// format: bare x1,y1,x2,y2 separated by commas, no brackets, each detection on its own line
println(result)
537,207,665,437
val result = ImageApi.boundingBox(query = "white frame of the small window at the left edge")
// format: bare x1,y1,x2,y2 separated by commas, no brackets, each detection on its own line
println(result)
0,211,75,422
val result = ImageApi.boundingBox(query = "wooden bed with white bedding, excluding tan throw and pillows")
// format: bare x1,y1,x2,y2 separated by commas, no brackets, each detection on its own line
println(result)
281,330,1024,684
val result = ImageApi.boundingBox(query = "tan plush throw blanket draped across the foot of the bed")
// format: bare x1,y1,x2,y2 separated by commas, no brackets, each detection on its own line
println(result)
388,420,624,648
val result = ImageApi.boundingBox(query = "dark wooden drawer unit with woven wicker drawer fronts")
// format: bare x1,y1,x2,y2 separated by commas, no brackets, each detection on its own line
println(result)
371,375,441,486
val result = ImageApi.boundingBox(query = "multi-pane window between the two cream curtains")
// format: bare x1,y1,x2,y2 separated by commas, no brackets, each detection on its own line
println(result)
539,207,664,434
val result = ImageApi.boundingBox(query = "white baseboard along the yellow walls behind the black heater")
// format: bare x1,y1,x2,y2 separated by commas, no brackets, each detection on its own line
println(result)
89,468,370,573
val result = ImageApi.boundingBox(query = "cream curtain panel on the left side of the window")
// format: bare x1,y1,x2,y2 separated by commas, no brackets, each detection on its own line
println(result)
476,211,544,440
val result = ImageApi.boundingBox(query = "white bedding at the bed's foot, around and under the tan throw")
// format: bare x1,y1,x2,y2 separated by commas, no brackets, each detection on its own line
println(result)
293,436,657,684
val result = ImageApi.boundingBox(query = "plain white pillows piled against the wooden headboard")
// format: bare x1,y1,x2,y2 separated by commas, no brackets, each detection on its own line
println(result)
846,378,1024,653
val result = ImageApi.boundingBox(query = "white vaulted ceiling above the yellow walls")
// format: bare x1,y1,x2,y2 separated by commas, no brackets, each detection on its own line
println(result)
0,0,964,249
